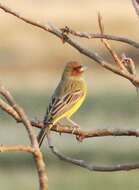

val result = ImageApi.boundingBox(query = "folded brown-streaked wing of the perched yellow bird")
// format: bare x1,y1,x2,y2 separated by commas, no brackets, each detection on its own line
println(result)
45,89,84,122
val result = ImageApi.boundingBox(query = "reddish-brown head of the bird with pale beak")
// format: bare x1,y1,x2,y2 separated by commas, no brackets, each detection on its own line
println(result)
63,61,86,78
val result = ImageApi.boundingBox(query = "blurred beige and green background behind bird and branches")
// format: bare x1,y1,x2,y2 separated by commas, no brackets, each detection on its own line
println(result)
0,0,139,190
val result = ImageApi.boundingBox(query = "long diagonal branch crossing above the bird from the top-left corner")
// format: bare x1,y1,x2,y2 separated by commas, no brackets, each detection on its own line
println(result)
0,3,139,89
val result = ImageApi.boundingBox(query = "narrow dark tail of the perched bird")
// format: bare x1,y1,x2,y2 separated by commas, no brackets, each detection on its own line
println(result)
37,123,52,147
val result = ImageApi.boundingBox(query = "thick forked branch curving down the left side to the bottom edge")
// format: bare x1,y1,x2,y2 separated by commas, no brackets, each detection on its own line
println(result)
0,84,48,190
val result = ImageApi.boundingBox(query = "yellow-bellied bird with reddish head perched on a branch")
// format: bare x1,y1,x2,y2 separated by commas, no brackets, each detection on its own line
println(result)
37,61,87,147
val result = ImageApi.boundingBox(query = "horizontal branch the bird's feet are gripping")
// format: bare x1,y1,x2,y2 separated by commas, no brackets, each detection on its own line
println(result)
0,99,139,139
